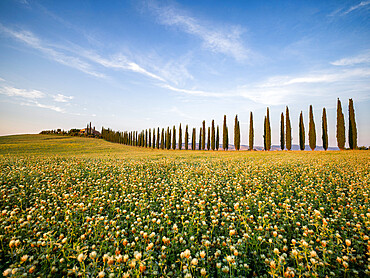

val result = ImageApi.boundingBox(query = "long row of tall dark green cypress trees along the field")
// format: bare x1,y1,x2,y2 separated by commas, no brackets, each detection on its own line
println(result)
102,98,357,150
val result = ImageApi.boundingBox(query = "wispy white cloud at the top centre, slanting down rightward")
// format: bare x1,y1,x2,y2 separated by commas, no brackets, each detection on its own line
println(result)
149,1,250,61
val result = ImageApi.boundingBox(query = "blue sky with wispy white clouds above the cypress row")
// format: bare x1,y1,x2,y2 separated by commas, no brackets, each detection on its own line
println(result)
0,0,370,147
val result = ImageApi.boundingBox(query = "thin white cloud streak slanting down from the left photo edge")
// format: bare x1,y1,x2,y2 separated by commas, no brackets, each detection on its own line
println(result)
0,24,105,78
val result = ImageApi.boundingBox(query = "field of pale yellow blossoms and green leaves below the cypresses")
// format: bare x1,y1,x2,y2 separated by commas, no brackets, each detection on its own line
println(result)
0,136,370,277
